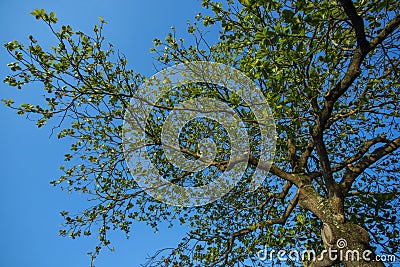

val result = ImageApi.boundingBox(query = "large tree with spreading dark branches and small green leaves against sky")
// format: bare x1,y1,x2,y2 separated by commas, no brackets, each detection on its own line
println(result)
3,0,400,266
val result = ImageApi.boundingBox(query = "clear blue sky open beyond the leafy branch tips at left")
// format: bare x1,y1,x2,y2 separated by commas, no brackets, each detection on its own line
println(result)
0,0,212,267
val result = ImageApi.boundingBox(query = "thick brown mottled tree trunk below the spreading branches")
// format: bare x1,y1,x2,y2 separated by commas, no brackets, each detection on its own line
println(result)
299,185,385,267
